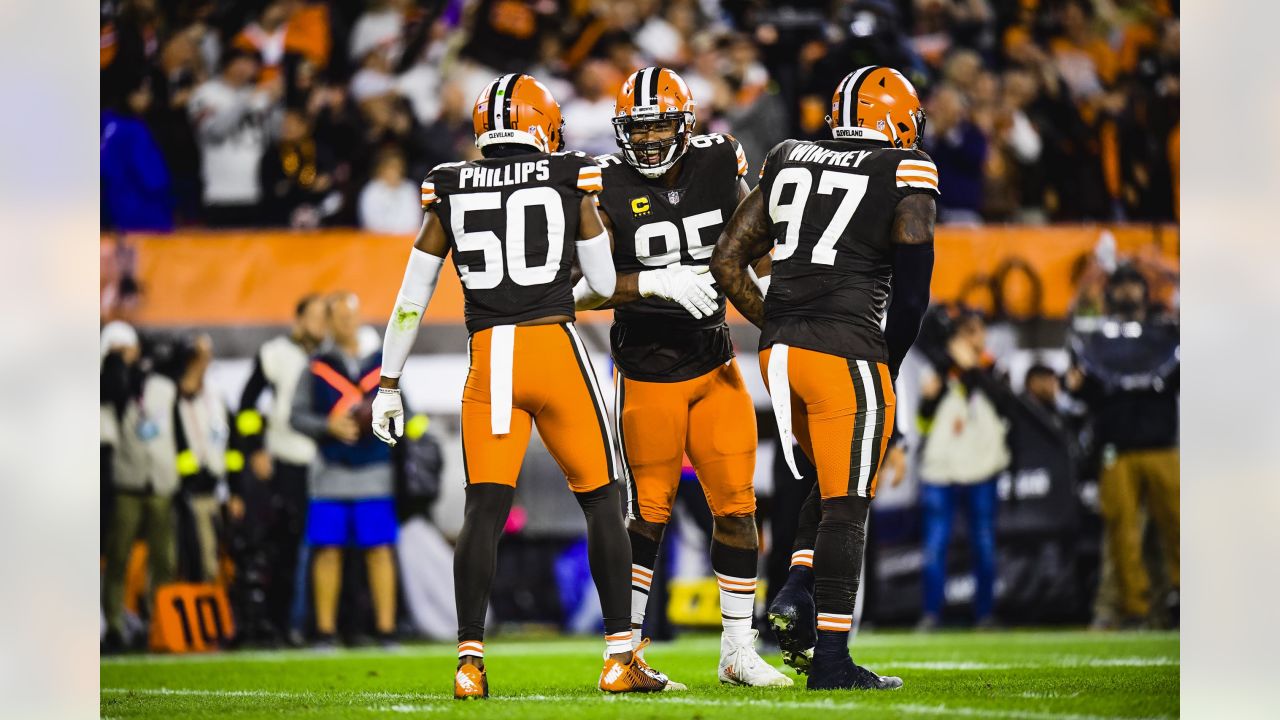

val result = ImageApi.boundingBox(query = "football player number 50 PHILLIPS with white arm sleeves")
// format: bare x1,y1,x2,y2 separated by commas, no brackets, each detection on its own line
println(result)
374,74,680,698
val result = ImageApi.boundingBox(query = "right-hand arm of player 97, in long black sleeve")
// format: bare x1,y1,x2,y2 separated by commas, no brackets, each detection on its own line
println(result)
884,192,937,378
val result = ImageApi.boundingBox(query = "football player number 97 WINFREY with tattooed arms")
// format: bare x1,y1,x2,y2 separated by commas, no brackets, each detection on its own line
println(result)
712,67,938,689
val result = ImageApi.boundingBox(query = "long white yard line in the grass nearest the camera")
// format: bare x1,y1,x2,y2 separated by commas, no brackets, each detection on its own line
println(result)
102,688,1172,720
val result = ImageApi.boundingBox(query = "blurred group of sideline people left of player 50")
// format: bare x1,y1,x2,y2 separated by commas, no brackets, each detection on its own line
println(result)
100,292,453,652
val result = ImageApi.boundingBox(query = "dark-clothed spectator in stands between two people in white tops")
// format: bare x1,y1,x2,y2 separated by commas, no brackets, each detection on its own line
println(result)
260,108,340,228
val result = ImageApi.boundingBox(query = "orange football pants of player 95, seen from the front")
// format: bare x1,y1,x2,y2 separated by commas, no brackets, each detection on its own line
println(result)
614,360,756,524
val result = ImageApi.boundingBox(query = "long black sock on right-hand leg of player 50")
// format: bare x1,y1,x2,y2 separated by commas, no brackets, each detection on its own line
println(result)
573,483,631,640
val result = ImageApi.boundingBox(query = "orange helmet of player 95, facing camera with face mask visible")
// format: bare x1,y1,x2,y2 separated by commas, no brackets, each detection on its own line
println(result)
613,67,698,178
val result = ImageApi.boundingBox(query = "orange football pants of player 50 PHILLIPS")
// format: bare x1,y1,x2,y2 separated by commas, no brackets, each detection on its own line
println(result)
462,323,617,492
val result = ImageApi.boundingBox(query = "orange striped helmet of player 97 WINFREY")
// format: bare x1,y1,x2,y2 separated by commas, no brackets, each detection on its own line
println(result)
827,65,924,147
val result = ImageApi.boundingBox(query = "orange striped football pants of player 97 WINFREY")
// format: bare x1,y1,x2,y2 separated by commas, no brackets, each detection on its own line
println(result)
760,347,896,500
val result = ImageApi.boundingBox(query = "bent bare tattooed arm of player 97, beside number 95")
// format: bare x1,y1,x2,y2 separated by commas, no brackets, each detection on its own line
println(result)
712,183,773,327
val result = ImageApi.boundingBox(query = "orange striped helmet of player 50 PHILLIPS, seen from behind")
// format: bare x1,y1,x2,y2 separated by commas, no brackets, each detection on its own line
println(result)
471,73,564,152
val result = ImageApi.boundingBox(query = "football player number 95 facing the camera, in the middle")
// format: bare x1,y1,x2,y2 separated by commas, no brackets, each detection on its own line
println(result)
575,68,792,687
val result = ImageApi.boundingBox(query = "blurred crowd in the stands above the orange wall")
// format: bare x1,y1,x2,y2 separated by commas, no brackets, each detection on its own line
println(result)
100,0,1179,233
